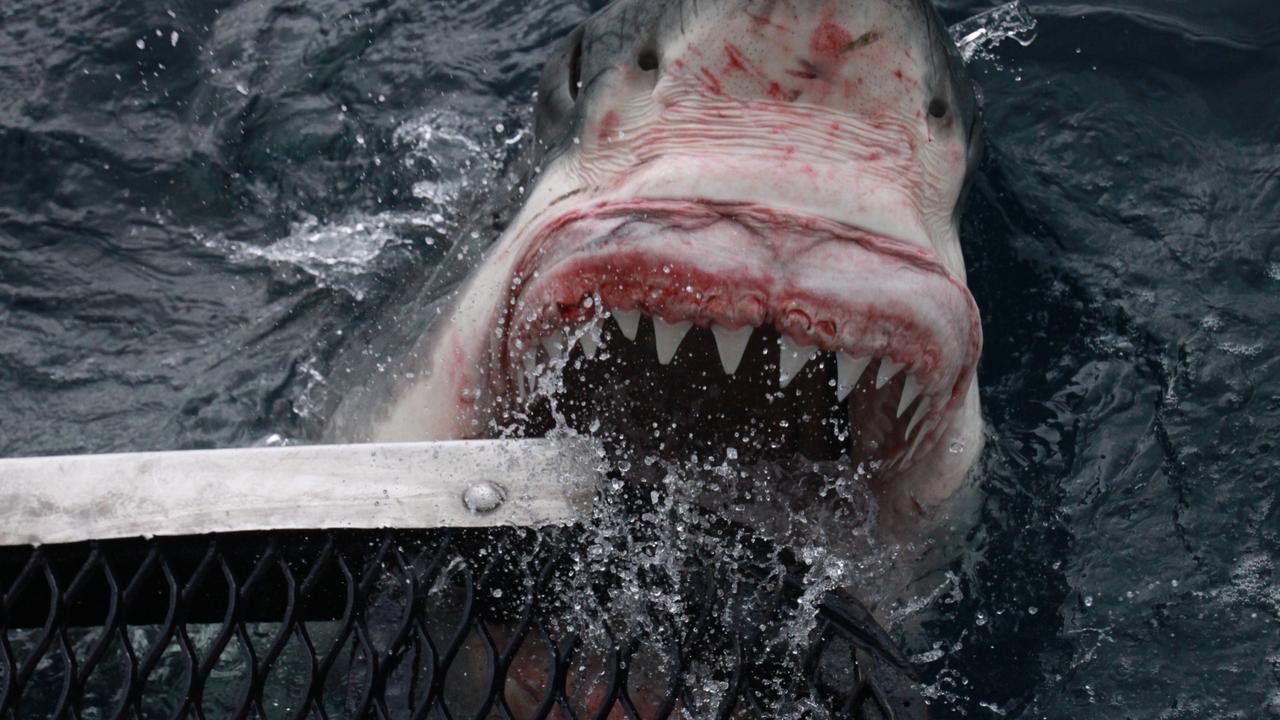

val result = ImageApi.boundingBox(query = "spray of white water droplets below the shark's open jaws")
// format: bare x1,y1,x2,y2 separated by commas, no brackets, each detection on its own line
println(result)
486,330,932,719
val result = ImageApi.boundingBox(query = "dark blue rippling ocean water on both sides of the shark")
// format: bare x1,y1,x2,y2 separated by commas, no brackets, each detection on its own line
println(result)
0,0,1280,719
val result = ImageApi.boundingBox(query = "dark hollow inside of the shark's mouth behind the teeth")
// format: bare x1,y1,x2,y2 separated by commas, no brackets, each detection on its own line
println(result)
509,318,906,471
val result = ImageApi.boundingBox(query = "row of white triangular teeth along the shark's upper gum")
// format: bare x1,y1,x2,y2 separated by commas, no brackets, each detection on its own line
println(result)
520,309,931,459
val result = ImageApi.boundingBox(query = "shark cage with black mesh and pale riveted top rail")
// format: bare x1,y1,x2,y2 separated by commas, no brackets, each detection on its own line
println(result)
0,441,928,720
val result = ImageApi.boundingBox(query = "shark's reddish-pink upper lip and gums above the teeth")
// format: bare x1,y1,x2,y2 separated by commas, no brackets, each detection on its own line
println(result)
504,201,982,420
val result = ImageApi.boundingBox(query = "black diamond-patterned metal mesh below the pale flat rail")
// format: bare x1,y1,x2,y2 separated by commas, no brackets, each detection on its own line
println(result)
0,528,925,719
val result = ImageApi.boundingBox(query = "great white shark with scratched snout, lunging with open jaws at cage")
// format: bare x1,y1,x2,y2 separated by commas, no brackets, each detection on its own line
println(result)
335,0,983,514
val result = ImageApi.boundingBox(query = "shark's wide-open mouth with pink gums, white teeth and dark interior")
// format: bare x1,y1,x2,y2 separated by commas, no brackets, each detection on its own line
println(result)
495,201,982,471
